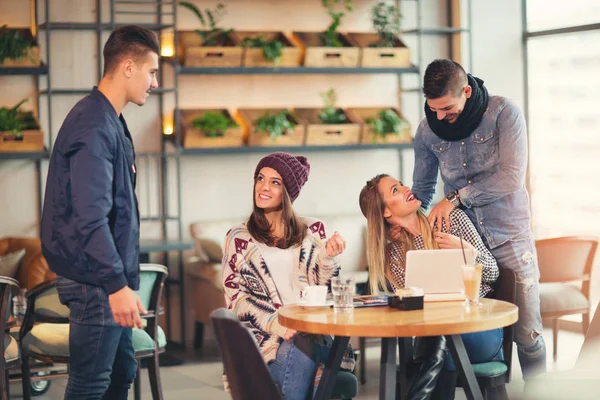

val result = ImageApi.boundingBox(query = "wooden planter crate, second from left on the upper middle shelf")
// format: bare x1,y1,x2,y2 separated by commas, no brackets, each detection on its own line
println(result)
231,31,302,67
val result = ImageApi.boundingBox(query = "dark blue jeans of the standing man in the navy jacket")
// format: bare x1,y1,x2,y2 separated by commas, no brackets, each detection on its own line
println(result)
57,277,137,400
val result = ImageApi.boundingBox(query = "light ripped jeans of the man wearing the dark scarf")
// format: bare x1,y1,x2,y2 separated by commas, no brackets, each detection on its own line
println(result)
491,231,546,379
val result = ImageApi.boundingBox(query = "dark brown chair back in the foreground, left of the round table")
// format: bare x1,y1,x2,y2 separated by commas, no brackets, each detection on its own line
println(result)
210,308,281,400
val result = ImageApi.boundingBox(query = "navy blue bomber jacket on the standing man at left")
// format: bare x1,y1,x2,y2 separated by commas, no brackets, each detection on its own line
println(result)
41,87,140,294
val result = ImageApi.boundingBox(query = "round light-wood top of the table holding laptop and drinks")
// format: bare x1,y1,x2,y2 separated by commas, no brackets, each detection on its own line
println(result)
278,299,518,337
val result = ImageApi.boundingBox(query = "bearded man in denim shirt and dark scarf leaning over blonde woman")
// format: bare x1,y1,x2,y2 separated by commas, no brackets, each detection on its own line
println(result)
412,60,546,379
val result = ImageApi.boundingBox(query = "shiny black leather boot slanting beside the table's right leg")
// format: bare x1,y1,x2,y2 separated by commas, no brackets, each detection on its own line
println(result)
407,336,448,400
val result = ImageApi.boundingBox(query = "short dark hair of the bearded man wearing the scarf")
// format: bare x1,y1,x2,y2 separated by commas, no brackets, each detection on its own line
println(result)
423,59,469,99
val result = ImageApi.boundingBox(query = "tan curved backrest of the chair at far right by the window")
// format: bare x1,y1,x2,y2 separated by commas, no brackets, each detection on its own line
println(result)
535,236,598,283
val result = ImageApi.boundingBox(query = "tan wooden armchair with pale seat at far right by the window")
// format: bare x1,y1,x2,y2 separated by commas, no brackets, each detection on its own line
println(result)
535,236,598,361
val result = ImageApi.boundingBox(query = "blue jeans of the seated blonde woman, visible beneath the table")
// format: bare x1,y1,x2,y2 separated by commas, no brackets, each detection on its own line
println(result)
444,328,504,371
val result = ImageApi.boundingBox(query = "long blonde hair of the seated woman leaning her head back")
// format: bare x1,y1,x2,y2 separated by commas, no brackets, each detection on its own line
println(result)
358,174,438,293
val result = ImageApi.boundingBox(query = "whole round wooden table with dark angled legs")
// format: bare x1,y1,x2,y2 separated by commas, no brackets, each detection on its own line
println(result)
278,299,518,399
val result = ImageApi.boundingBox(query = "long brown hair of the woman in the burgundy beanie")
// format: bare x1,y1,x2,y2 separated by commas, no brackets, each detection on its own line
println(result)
246,179,308,249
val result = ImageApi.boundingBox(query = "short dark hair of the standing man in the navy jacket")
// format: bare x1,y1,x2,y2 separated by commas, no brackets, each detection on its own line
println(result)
103,25,160,75
